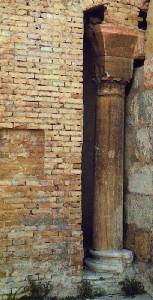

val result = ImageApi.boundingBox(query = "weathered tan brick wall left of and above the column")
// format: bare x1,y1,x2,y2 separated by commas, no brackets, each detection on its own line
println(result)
0,0,149,297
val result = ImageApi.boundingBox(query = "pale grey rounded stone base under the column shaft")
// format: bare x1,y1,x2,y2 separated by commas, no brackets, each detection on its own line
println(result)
86,249,133,274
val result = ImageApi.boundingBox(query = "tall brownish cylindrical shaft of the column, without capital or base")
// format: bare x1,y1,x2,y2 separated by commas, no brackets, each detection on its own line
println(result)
93,81,124,250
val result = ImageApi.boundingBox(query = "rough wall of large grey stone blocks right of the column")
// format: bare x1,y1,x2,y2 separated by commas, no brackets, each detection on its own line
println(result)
125,3,153,272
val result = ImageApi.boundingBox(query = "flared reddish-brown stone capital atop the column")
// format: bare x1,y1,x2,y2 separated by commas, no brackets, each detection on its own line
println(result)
89,23,139,84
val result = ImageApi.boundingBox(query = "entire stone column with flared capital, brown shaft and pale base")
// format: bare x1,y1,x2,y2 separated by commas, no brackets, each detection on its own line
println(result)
86,24,138,273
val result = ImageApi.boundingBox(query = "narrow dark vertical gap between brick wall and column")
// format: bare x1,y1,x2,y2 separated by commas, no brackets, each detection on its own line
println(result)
82,5,104,256
